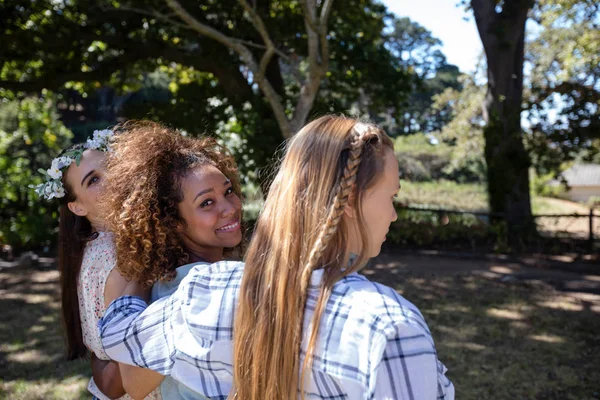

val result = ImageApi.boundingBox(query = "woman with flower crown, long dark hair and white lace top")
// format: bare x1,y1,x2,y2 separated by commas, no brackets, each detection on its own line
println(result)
35,130,160,400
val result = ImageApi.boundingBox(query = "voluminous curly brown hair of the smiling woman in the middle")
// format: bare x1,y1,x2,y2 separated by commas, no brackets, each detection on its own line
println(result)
100,121,242,286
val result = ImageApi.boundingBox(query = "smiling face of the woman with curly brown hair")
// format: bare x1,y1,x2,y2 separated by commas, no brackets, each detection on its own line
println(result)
178,165,242,262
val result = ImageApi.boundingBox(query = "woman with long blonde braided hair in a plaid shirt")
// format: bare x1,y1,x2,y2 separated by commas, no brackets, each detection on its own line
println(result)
101,116,454,400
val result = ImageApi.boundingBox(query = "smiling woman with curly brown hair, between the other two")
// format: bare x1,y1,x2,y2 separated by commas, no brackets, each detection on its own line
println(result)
100,121,243,399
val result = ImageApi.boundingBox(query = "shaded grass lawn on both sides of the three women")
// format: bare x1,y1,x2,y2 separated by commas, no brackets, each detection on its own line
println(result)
0,260,600,400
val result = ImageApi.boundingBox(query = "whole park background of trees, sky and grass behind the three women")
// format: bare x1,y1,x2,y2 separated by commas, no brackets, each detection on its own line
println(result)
0,0,600,399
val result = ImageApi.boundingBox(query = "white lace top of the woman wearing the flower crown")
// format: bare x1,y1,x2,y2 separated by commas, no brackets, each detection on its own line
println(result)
77,232,161,400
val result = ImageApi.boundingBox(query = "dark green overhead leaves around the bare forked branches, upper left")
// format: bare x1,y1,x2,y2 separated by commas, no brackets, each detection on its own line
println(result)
0,0,410,168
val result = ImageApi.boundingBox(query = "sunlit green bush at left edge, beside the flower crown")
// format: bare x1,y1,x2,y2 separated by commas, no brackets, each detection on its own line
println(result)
0,94,72,249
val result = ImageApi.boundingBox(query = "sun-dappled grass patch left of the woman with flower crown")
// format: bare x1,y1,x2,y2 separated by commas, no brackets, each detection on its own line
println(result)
0,266,90,399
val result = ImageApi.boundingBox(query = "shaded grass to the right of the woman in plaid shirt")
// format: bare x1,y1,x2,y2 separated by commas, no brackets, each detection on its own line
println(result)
364,263,600,400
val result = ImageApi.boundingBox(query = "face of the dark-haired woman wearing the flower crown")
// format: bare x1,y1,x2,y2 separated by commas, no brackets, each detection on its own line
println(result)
65,150,106,229
